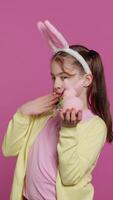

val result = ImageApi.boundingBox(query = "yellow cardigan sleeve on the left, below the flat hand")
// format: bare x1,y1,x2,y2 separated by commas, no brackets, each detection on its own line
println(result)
2,111,31,157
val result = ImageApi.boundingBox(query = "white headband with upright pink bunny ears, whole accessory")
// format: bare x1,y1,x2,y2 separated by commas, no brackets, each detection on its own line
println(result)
37,20,92,74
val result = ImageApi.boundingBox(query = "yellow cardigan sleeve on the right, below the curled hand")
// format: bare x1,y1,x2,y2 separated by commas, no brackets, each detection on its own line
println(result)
57,117,107,185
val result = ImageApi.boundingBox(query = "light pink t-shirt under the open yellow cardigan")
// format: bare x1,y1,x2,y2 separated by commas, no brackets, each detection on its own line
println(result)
23,110,94,200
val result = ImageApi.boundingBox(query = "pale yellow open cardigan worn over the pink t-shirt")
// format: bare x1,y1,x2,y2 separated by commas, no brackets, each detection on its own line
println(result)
2,111,107,200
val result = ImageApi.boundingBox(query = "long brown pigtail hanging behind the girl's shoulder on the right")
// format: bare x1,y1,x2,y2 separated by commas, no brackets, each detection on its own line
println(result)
87,50,113,143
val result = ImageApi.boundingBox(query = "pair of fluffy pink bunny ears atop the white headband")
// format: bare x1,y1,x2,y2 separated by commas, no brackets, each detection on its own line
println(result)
37,20,69,52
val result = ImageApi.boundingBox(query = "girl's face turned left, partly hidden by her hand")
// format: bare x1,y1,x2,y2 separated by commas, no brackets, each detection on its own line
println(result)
51,59,83,96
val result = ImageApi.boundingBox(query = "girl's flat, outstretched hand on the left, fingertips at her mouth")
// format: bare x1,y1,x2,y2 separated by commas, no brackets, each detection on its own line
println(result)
18,94,59,115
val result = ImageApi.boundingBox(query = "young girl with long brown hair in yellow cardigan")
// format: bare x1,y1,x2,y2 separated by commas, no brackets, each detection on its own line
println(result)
2,20,113,200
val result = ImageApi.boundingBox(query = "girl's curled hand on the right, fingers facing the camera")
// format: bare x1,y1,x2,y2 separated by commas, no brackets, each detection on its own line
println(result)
60,108,82,127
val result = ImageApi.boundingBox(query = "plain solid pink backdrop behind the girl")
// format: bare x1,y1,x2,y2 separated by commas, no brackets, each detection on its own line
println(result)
0,0,113,200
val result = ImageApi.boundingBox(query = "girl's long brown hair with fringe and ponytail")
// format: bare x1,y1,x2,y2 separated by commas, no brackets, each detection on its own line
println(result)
51,45,113,143
